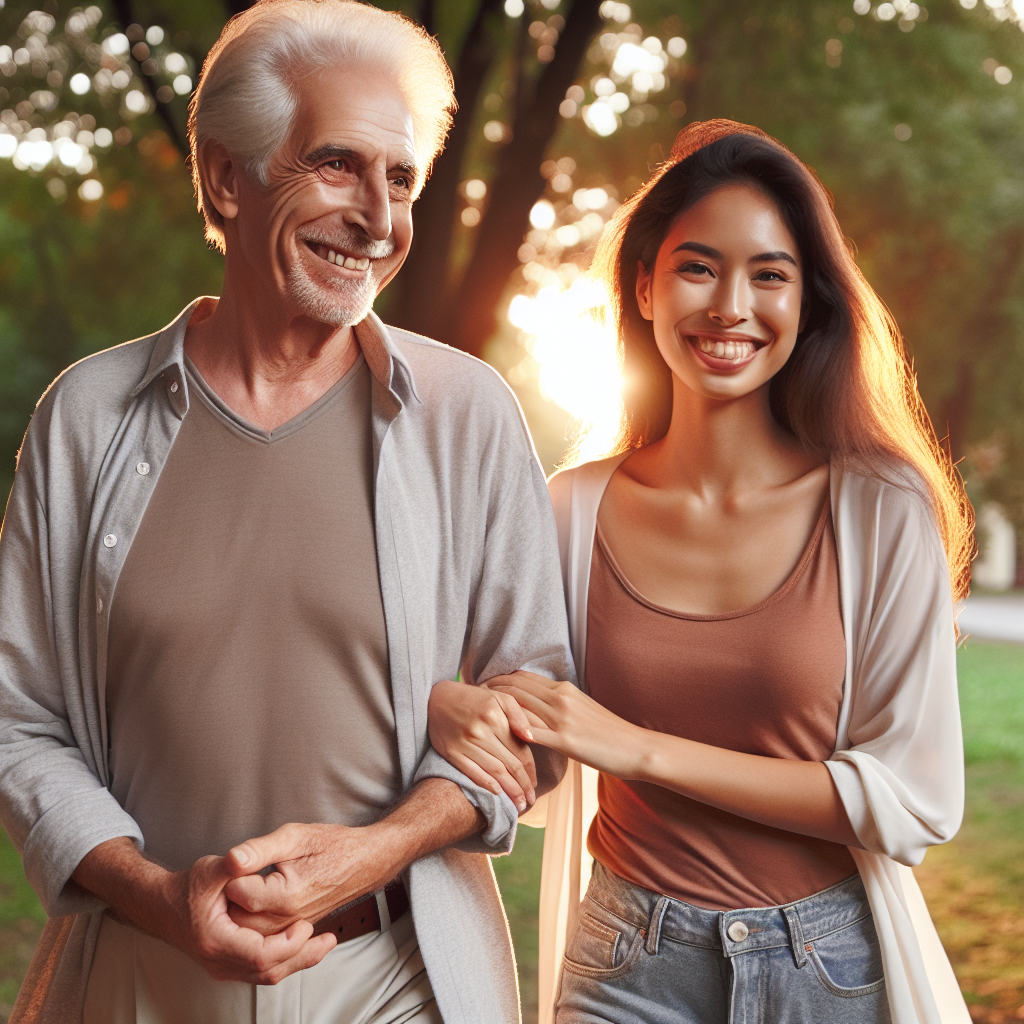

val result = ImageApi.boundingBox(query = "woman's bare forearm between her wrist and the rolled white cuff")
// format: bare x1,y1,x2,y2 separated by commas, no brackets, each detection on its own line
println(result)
630,729,860,847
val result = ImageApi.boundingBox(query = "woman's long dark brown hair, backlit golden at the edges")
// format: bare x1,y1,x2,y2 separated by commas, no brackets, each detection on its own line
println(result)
592,121,974,600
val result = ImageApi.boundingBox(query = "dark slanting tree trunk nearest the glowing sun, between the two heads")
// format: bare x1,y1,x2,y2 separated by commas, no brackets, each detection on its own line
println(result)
452,0,600,355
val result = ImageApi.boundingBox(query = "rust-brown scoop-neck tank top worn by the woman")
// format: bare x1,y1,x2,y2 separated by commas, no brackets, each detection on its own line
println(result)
587,502,856,910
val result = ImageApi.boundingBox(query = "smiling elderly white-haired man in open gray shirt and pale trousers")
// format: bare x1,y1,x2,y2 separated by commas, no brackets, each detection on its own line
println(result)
0,0,572,1024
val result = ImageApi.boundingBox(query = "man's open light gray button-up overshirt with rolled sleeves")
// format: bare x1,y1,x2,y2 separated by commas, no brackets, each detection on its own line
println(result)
0,304,574,1024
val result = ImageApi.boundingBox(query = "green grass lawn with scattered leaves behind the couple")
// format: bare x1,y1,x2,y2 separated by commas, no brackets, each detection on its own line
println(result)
0,641,1024,1024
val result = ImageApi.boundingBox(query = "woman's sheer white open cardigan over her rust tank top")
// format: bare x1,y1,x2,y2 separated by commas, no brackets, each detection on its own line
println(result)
524,455,971,1024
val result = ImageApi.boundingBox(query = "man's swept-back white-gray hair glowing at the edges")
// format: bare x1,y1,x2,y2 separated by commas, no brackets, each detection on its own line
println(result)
188,0,455,251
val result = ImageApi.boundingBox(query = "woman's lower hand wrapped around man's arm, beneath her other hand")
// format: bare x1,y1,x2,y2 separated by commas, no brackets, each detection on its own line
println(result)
427,677,537,813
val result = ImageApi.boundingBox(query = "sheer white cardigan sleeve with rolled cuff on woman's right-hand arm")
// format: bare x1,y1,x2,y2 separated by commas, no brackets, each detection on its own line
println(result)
826,474,964,865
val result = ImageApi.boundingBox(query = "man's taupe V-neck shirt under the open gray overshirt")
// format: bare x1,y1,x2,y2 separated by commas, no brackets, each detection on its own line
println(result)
106,355,401,869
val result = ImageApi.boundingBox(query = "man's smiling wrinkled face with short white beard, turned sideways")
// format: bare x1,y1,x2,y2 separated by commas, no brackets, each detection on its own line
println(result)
228,67,422,327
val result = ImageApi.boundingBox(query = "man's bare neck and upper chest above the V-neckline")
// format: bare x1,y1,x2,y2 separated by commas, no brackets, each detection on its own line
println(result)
184,278,359,430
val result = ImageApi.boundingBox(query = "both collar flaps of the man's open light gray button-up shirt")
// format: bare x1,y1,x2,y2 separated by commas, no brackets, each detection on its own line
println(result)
131,296,421,416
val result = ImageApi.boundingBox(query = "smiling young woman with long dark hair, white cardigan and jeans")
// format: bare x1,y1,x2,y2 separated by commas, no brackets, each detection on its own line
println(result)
431,122,972,1024
